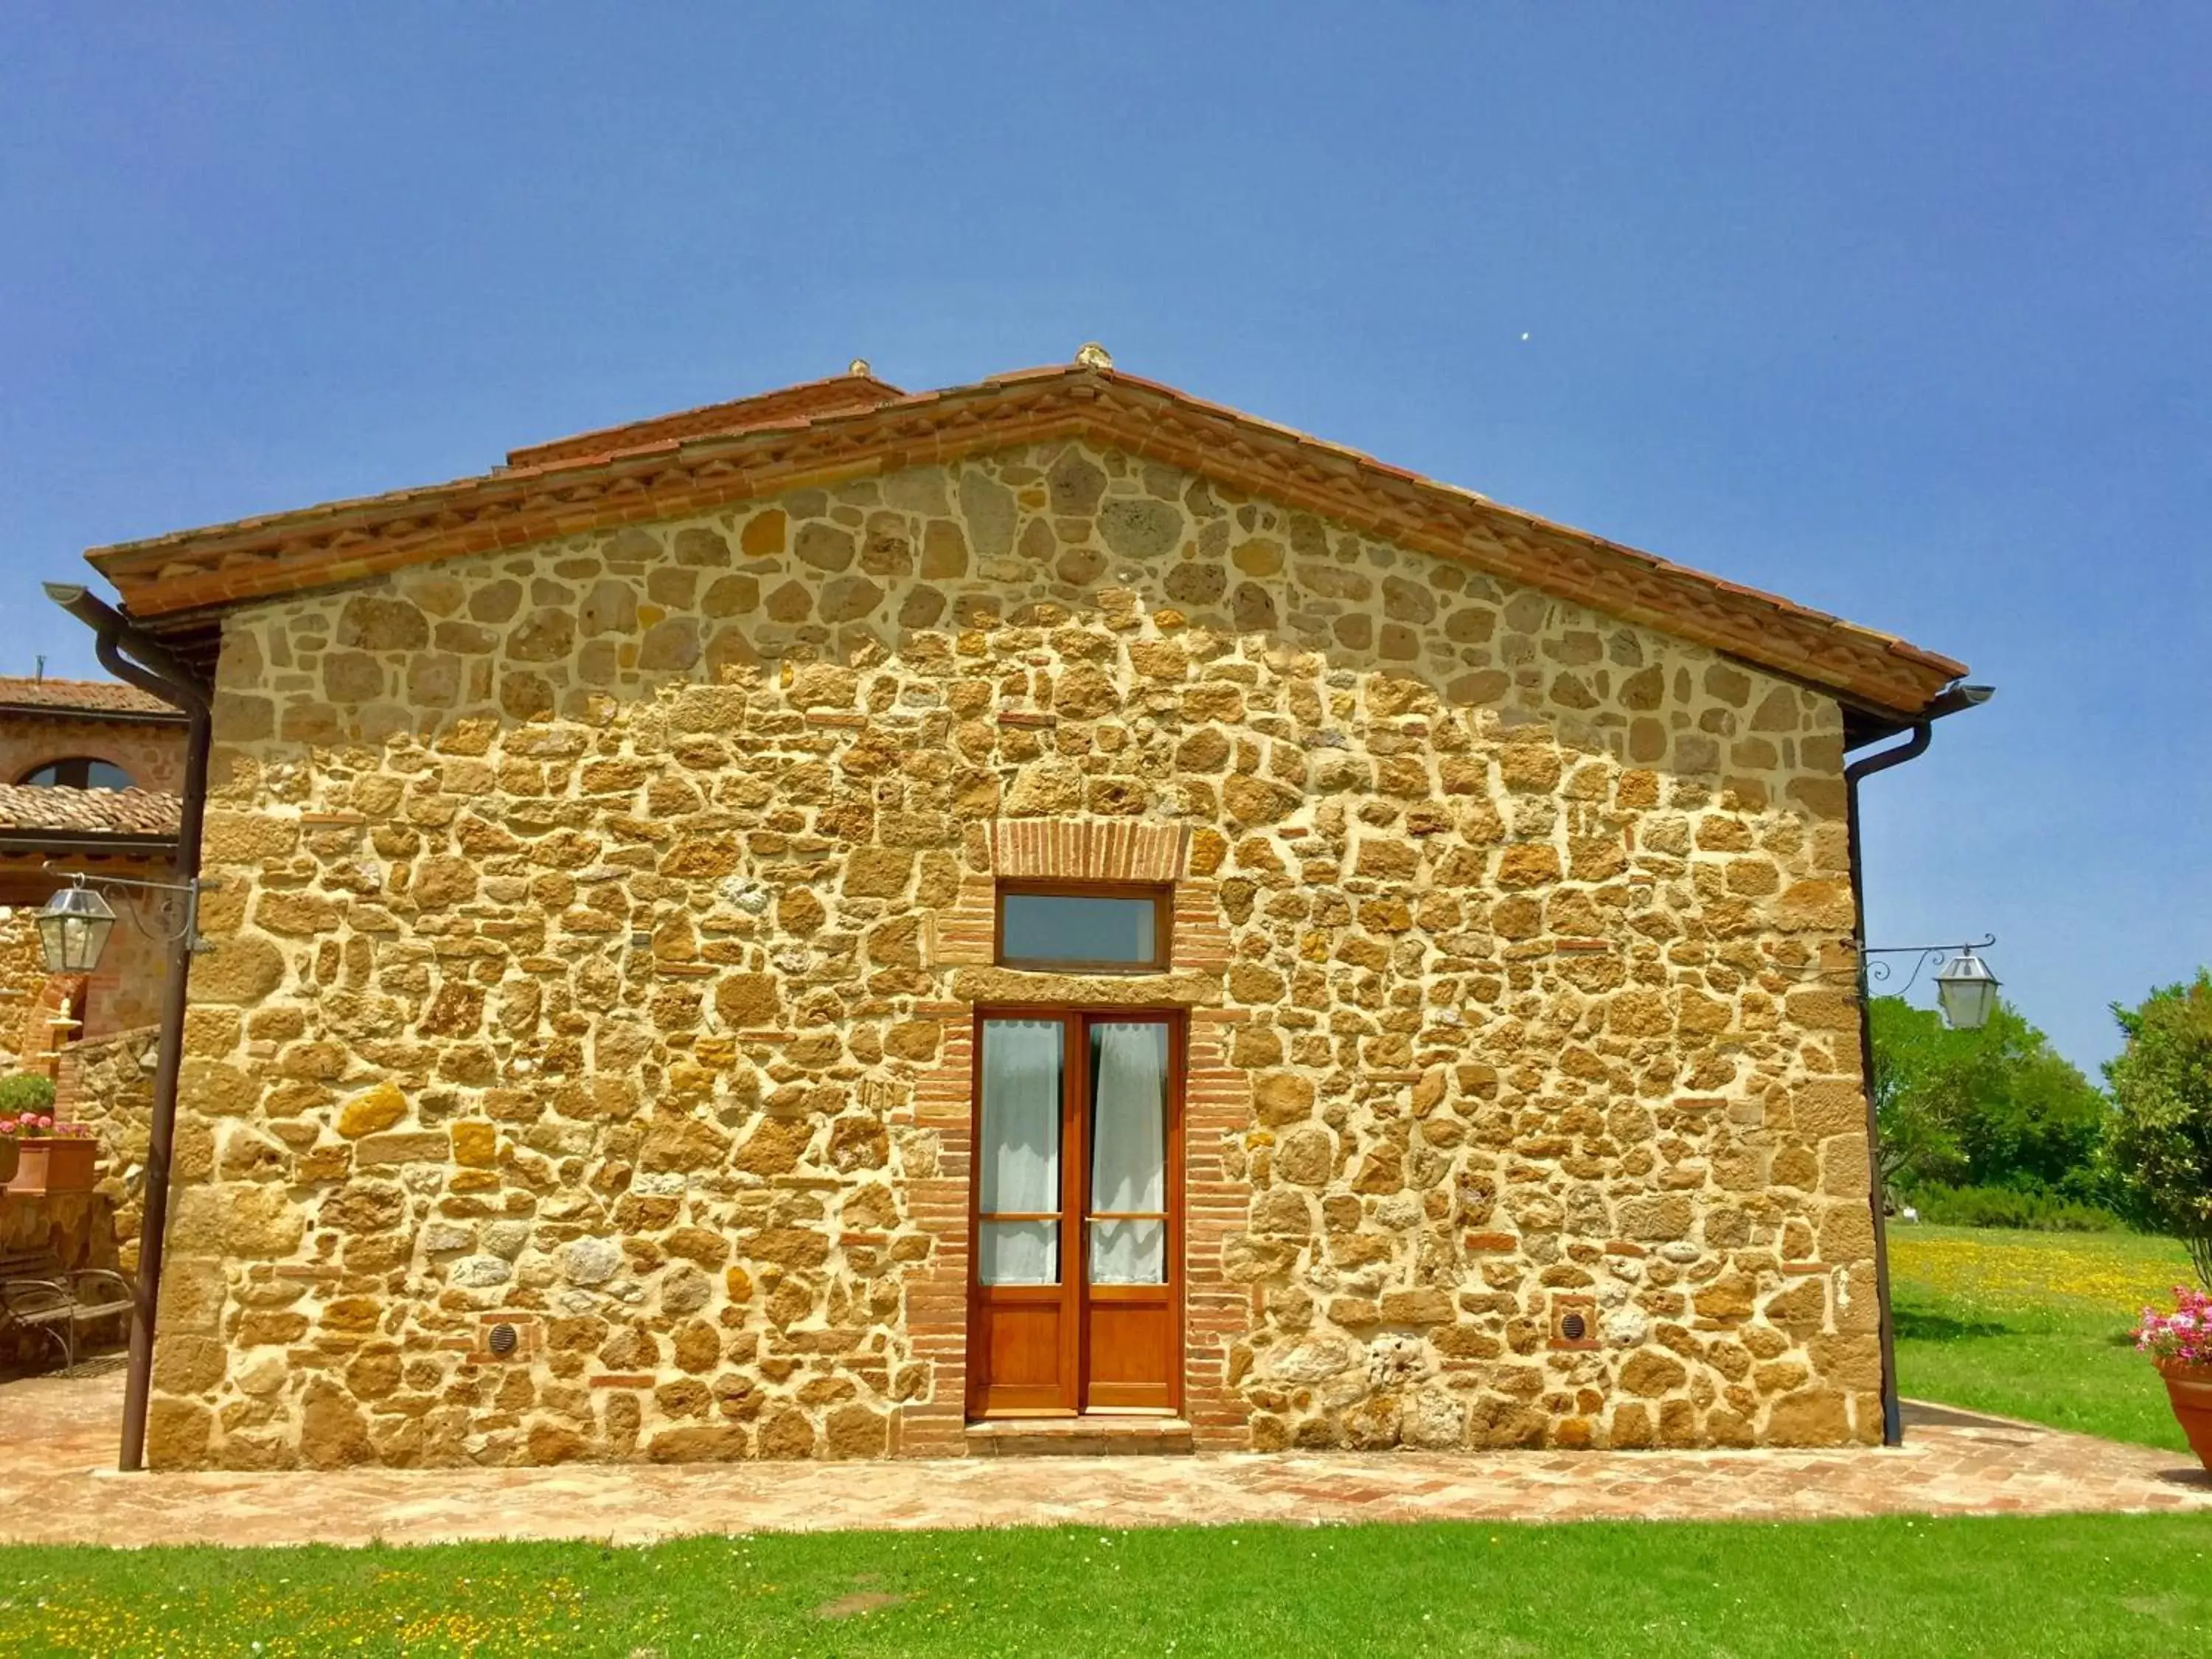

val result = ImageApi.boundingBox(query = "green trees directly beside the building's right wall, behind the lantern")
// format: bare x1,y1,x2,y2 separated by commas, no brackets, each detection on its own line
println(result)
1869,998,2112,1201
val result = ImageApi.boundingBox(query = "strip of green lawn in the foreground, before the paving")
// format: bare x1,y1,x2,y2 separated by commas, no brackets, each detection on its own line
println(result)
0,1515,2212,1659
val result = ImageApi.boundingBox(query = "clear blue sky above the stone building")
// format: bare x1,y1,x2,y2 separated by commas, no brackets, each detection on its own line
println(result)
0,0,2212,1064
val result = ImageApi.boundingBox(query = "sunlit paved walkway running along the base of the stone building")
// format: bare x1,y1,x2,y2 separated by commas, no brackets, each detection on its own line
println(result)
0,1363,2212,1544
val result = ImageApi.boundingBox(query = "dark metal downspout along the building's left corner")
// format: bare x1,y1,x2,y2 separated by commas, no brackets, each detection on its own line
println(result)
46,582,212,1473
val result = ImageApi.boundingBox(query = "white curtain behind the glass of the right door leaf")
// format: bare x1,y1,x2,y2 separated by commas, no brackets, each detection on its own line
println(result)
1091,1022,1168,1285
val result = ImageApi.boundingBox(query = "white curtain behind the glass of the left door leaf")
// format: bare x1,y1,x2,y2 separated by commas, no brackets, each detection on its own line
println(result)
975,1020,1064,1285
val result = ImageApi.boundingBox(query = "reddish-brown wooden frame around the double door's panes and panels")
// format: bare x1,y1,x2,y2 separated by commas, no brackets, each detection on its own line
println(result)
964,1002,1190,1422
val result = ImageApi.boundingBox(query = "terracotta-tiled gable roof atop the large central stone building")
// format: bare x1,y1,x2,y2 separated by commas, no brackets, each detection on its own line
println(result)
86,352,1966,717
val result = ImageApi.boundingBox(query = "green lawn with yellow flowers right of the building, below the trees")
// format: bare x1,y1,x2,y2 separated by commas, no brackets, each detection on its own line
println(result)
1889,1223,2192,1451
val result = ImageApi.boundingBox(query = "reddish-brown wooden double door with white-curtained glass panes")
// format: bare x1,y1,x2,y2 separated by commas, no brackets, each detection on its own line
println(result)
967,1009,1183,1418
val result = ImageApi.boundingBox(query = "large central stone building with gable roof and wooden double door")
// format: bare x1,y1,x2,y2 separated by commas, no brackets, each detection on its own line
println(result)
73,354,1962,1469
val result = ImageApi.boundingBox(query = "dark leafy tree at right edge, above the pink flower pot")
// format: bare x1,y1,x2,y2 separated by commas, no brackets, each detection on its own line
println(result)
2104,969,2212,1287
